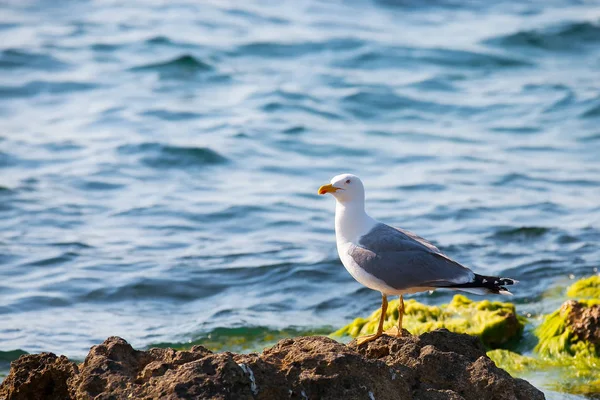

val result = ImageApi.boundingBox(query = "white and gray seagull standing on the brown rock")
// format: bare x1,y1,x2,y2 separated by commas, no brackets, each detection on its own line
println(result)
318,174,518,345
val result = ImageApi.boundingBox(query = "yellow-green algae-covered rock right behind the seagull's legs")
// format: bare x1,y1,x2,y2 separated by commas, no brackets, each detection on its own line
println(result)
332,295,525,348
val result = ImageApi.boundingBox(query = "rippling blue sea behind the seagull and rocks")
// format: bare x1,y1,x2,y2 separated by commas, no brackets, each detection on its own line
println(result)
0,0,600,396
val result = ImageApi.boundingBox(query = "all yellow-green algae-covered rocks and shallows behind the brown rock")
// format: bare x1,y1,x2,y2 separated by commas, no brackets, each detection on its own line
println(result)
333,275,600,398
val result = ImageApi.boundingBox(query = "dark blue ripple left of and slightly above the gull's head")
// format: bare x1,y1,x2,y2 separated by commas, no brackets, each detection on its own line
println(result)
117,143,227,169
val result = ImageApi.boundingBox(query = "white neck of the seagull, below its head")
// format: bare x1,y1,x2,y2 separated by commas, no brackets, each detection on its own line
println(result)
335,199,377,243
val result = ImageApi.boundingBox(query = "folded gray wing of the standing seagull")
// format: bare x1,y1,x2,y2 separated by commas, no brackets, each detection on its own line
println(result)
349,223,474,290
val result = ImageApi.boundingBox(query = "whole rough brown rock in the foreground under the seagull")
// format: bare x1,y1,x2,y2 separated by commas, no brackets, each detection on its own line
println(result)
0,330,544,400
